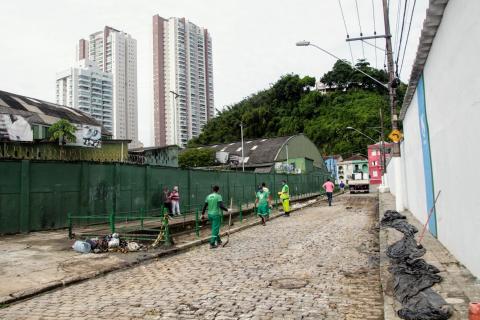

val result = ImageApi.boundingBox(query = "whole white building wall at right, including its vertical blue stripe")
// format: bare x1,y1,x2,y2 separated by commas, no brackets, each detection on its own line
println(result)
387,0,480,277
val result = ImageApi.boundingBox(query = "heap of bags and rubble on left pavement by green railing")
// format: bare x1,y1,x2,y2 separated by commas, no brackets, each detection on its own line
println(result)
72,233,146,253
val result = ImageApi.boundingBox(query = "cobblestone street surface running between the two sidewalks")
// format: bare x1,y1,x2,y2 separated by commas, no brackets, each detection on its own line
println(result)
0,195,383,319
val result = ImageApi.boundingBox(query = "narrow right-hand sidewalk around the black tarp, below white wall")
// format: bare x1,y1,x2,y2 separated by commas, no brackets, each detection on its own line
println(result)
379,193,480,320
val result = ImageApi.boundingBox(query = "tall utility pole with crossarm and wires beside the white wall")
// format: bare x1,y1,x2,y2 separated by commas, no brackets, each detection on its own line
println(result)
382,0,400,157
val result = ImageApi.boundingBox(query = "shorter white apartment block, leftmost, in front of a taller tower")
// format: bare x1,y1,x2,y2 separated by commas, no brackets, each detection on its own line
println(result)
56,59,113,132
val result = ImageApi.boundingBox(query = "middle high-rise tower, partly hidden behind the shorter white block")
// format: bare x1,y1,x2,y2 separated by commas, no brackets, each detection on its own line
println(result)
77,26,139,147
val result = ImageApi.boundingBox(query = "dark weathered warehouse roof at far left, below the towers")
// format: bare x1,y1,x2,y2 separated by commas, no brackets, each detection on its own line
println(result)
0,90,111,135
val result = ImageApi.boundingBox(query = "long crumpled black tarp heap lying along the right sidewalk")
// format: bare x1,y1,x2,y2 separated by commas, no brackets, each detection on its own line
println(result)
381,210,451,320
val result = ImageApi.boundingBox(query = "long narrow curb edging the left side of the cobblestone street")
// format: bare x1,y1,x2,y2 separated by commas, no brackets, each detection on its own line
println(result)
0,195,322,307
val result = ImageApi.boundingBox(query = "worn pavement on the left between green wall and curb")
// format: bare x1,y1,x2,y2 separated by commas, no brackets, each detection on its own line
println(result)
0,197,318,306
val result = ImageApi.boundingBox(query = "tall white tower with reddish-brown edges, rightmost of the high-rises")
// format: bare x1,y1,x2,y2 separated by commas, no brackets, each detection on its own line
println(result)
153,15,214,146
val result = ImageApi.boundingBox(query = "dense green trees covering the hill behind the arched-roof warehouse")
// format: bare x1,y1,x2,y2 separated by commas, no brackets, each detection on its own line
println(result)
189,60,405,155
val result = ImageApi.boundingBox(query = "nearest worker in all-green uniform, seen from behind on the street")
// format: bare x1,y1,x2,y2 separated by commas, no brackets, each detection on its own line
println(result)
202,186,231,249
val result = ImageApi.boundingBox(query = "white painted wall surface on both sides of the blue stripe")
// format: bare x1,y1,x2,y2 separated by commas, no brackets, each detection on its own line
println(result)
400,0,480,277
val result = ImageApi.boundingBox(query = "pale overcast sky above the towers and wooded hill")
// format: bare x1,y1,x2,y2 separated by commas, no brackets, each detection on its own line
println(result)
0,0,428,146
